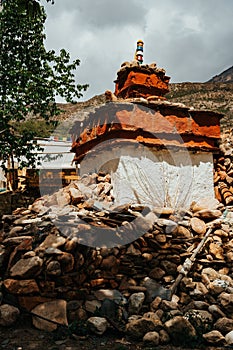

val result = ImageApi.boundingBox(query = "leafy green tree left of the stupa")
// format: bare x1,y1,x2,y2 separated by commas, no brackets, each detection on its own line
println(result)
0,0,88,187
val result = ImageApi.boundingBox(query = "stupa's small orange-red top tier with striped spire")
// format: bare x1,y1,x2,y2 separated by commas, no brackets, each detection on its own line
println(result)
114,40,170,99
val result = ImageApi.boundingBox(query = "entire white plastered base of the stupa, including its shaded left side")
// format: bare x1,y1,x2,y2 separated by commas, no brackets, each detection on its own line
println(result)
78,143,214,209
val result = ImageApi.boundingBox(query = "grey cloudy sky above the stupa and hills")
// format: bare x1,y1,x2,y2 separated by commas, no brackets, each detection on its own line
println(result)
41,0,233,100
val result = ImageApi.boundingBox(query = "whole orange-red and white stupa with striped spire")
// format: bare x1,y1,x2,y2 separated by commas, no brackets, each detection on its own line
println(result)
72,41,222,209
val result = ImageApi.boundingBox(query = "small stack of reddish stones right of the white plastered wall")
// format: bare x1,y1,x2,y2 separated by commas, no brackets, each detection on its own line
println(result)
214,129,233,205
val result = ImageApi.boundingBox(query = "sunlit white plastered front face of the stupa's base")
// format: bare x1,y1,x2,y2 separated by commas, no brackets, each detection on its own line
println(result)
112,150,214,209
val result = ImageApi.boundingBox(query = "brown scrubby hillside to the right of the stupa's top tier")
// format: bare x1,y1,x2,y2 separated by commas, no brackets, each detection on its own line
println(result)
166,82,233,130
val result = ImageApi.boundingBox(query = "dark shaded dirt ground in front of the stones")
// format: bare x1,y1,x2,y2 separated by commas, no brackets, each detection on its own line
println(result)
0,318,223,350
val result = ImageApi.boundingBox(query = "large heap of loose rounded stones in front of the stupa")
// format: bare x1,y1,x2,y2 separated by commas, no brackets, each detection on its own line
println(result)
0,174,233,346
